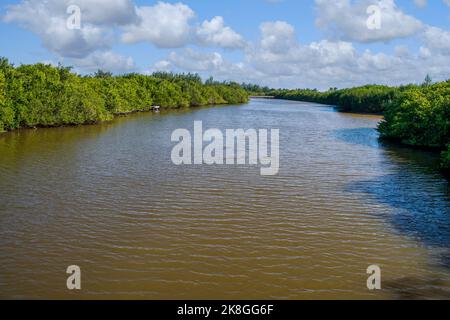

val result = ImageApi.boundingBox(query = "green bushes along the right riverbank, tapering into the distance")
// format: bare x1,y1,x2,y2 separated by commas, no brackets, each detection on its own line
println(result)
242,80,450,171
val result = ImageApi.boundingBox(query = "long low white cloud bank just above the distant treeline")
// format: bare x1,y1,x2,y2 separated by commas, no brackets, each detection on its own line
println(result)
155,21,450,89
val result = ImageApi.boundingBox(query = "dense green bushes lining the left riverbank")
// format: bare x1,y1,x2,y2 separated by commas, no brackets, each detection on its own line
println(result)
0,59,248,131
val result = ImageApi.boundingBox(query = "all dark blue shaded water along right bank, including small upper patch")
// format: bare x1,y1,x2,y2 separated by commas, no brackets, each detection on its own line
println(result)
336,128,450,262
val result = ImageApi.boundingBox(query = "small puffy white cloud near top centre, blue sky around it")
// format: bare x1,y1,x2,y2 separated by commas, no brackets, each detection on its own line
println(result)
197,16,245,49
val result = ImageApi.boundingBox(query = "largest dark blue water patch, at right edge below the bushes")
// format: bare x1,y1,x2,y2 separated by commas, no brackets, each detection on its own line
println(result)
354,166,450,262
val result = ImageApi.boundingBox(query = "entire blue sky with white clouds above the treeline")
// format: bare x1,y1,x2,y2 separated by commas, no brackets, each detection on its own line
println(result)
0,0,450,90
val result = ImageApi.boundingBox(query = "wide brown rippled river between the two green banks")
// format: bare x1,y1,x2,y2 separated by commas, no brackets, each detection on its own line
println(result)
0,100,450,299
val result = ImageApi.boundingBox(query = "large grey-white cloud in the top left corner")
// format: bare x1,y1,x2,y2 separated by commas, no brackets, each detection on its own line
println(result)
3,0,135,58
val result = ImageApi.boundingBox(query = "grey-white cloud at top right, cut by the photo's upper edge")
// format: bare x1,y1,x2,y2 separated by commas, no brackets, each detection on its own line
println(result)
315,0,424,43
